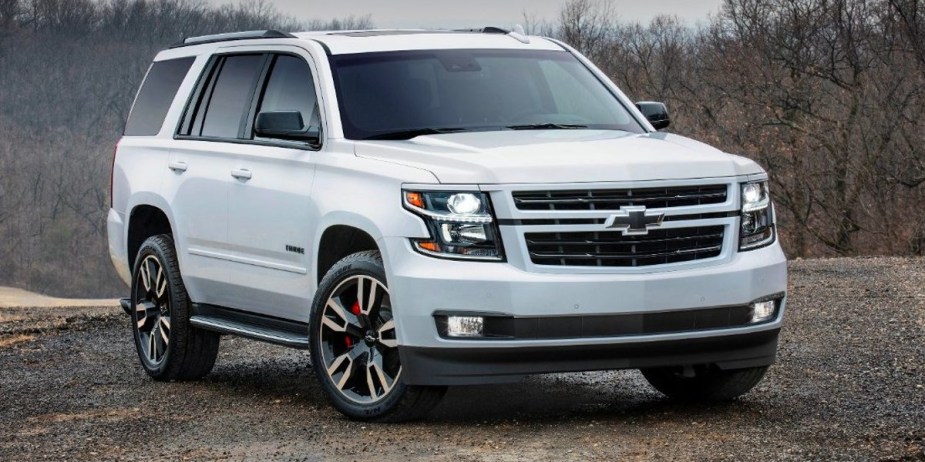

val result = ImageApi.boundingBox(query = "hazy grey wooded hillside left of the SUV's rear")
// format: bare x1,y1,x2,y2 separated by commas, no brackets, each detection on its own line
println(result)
0,0,371,297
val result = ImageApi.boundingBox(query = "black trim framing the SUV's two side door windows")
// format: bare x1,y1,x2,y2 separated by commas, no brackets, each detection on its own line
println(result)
173,50,325,151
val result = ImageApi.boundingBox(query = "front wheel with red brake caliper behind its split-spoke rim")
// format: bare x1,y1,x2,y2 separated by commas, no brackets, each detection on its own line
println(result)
309,251,446,422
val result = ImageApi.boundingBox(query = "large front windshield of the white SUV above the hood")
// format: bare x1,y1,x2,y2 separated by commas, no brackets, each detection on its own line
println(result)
331,50,644,140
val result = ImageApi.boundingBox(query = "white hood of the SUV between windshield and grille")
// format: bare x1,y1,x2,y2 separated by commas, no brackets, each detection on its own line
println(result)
355,130,762,184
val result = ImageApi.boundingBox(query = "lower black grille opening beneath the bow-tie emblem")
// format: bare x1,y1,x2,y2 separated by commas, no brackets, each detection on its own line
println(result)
524,226,725,267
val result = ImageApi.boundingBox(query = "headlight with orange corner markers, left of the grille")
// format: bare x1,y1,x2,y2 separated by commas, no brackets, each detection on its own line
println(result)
402,191,504,261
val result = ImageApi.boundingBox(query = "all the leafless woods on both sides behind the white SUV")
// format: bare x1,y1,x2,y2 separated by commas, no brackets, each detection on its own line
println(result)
0,0,925,297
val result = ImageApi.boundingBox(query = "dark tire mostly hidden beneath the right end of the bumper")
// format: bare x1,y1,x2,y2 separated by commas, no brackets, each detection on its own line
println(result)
642,366,768,401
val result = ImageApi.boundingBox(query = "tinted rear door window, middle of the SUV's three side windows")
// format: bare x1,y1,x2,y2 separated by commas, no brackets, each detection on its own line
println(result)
202,55,265,138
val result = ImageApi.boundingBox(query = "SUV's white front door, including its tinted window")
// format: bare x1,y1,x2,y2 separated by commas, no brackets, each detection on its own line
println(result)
228,53,321,321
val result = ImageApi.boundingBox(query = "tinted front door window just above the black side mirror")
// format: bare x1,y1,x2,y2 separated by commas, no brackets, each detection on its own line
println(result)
258,55,319,130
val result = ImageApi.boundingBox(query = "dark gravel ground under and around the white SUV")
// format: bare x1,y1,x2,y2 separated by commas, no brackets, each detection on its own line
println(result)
0,258,925,461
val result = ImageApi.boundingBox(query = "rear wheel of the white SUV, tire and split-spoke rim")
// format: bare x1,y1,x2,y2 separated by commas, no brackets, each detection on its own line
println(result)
131,234,220,381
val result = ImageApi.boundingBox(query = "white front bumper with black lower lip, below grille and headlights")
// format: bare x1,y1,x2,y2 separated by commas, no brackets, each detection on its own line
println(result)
380,237,787,384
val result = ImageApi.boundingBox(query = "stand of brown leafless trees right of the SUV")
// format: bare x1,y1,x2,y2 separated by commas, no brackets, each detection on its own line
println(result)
540,0,925,255
